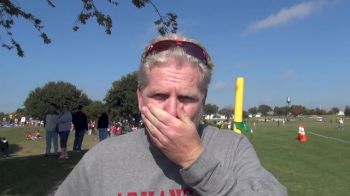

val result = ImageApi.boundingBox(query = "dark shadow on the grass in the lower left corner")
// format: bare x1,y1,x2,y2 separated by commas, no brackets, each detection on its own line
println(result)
0,151,86,196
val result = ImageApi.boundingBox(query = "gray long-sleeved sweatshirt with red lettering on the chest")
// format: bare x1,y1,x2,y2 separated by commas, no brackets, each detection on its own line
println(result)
55,126,287,196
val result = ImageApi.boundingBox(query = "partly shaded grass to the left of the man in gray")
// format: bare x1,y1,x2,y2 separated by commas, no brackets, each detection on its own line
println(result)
0,127,98,196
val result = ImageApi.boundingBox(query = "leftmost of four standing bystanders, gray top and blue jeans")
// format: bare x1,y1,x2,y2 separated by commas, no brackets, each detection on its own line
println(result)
44,103,58,157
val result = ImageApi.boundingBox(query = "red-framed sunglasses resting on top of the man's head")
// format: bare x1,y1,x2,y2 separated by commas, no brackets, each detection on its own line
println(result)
145,40,208,65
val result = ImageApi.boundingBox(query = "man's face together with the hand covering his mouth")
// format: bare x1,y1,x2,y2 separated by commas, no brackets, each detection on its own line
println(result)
137,59,205,168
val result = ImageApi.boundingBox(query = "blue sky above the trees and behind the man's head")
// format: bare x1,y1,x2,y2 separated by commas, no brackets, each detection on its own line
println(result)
0,0,350,112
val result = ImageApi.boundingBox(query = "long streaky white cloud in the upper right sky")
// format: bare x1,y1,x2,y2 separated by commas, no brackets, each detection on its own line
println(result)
248,1,324,33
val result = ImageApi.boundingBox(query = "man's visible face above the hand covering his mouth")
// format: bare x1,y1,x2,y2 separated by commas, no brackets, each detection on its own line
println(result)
137,59,205,126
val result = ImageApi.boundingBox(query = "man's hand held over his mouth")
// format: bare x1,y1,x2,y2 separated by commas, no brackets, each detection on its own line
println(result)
141,105,203,168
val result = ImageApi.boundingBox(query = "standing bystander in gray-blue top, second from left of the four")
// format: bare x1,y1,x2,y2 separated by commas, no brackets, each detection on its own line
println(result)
58,105,72,160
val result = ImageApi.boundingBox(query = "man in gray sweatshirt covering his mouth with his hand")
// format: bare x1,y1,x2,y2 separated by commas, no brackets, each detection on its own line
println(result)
56,34,287,196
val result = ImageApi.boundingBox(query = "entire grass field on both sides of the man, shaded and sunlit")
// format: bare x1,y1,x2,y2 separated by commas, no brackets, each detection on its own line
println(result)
0,119,350,196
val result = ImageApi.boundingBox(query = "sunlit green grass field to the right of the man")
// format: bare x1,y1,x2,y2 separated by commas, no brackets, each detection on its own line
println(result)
250,120,350,196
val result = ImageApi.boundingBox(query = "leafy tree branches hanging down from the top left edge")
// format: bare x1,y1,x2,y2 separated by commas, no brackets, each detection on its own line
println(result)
0,0,178,57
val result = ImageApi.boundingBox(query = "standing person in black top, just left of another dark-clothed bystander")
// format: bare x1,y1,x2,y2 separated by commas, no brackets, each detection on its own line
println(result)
72,105,88,152
